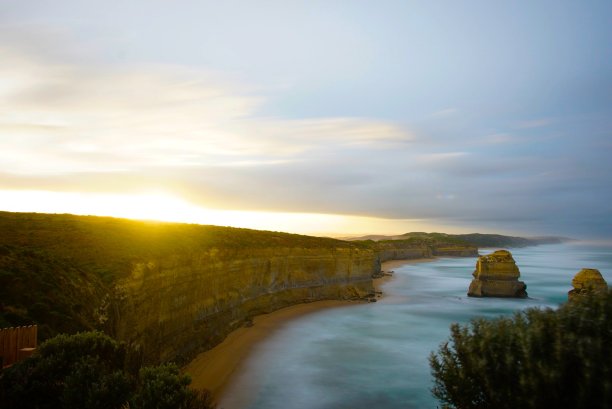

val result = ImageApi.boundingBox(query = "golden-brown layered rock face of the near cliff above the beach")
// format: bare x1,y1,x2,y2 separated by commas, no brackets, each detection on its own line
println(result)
112,248,380,362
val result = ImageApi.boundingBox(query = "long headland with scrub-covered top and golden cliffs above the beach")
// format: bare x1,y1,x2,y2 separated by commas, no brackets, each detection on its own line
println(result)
0,212,477,363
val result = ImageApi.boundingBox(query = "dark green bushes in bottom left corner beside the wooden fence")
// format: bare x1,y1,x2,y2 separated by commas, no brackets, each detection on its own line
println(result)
0,332,213,409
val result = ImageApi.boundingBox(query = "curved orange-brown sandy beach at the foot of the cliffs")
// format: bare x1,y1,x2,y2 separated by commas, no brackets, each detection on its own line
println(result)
181,257,436,402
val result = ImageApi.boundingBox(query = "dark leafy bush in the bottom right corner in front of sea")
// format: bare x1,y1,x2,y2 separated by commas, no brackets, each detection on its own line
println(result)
430,291,612,409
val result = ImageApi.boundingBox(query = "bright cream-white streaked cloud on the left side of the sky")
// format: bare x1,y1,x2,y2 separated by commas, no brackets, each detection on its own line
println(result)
0,41,411,175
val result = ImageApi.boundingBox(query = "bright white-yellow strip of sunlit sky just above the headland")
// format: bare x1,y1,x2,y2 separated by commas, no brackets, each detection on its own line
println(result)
0,190,431,236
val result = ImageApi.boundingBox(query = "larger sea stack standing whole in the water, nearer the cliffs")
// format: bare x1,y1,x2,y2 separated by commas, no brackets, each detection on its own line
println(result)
468,250,527,298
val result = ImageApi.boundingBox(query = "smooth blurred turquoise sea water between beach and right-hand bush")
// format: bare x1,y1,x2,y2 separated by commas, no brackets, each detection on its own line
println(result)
219,244,612,409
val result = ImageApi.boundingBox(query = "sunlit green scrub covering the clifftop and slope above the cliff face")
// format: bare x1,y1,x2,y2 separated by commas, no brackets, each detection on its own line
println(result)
0,212,367,339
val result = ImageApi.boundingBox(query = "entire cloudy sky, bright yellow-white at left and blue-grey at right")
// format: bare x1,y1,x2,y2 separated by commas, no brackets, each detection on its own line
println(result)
0,0,612,239
